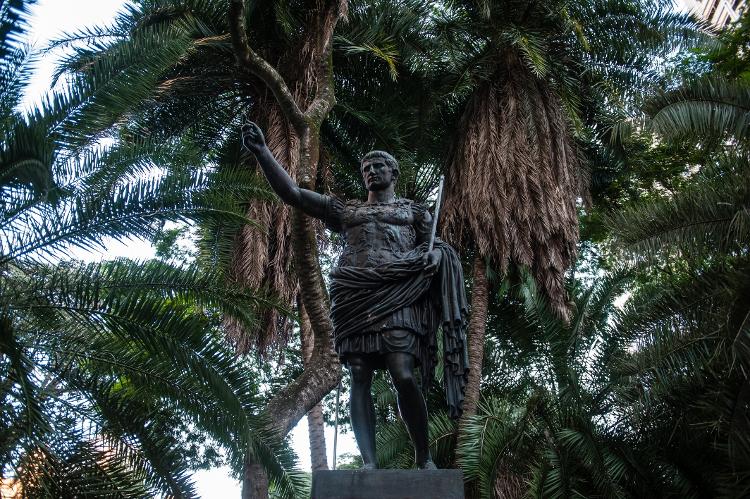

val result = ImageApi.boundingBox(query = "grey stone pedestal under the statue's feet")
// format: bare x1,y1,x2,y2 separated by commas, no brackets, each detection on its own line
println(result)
311,470,464,499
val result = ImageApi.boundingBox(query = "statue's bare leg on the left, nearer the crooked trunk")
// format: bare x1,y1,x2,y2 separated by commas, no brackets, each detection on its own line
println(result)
346,355,377,469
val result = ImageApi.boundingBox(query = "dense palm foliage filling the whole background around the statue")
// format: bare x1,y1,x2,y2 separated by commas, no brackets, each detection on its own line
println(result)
0,0,750,498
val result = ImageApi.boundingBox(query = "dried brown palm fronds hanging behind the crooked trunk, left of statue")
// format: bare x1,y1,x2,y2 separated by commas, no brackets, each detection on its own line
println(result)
225,2,338,355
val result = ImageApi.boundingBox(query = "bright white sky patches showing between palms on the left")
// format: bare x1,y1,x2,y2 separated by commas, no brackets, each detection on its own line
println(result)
22,0,359,499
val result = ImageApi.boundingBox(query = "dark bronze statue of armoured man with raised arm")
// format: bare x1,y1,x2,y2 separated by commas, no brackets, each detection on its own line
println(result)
242,123,468,469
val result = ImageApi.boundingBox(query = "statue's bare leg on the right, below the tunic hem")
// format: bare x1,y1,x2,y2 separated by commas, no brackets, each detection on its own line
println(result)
385,352,435,469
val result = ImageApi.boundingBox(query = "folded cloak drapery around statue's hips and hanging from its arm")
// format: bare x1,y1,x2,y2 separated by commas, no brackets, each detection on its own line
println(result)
330,239,469,418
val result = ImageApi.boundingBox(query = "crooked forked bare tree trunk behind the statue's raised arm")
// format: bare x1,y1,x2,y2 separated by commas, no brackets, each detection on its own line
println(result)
229,0,346,442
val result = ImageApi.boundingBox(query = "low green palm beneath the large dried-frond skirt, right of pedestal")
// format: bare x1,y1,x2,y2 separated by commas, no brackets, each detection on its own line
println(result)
456,272,638,498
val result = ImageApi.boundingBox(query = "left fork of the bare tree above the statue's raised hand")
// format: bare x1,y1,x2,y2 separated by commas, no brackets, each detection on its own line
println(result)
229,0,308,135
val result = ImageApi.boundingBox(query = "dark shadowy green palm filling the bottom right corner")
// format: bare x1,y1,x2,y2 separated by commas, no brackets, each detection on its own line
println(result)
616,257,750,497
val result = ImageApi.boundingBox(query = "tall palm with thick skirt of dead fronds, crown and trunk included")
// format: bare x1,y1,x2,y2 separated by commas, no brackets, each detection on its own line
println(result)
430,0,696,432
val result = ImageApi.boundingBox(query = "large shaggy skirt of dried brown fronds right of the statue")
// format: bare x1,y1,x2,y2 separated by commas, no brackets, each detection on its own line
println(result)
442,54,579,318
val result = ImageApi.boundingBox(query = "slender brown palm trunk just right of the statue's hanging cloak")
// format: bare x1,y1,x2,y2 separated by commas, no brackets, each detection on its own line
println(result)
459,253,488,428
